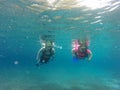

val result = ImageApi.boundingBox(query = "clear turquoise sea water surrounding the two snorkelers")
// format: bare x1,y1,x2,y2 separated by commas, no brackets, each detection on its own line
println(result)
0,0,120,90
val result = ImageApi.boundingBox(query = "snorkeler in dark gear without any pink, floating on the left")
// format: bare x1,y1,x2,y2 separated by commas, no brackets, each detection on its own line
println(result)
36,41,55,66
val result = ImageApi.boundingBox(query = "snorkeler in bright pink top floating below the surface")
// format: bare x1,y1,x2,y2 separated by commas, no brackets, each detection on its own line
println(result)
72,39,92,61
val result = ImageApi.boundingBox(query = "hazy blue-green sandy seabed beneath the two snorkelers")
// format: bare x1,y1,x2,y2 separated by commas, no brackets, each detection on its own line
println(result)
0,66,120,90
